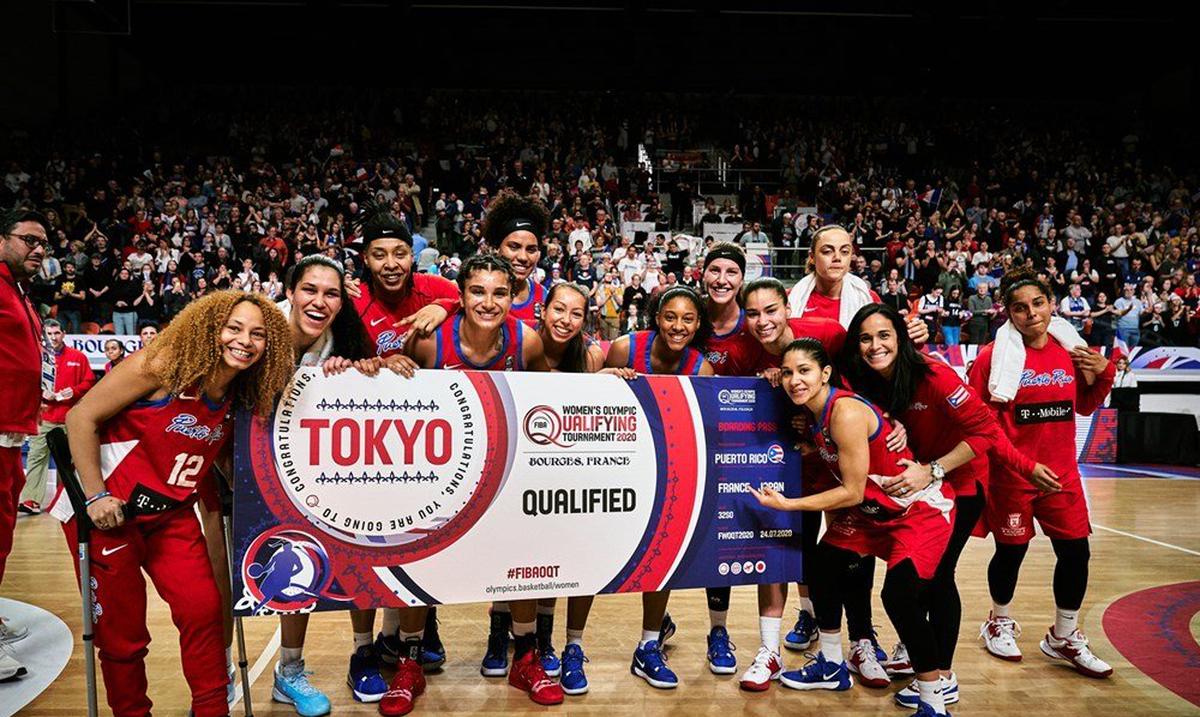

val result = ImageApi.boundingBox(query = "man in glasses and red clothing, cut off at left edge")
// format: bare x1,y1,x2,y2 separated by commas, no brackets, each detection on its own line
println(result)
0,210,50,680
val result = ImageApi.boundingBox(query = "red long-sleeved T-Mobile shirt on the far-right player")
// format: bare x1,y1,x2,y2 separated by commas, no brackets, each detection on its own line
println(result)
967,338,1116,484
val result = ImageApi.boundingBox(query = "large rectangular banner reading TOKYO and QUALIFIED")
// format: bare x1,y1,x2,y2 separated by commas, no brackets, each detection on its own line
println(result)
234,369,802,615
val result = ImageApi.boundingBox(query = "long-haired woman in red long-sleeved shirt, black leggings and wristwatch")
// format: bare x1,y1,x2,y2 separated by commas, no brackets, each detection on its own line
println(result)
839,303,1052,707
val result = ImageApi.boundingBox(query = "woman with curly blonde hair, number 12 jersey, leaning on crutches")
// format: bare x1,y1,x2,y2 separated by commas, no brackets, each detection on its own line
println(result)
50,291,294,717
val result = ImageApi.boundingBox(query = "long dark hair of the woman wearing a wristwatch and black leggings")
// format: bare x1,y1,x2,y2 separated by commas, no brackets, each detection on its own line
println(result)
838,303,932,416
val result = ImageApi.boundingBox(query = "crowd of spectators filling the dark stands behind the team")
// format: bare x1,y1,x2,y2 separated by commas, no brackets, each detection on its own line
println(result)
0,89,1200,347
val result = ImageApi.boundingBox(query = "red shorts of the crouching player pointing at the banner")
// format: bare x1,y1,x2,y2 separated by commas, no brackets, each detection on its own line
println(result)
821,484,954,580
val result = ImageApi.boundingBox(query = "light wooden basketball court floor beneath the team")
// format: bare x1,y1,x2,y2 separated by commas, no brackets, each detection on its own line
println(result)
0,476,1200,717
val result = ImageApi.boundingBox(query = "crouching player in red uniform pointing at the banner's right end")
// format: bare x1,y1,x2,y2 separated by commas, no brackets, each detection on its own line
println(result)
751,338,954,717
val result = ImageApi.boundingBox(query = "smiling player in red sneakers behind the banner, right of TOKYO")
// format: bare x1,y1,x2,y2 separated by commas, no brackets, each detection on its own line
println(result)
393,254,563,716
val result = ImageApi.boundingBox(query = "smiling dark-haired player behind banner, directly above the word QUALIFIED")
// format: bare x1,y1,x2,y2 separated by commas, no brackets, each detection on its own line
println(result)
605,285,715,689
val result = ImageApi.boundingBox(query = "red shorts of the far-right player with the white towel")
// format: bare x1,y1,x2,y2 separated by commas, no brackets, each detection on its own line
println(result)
984,476,1092,546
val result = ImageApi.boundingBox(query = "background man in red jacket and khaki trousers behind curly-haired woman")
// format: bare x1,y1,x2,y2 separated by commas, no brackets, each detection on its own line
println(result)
17,319,96,516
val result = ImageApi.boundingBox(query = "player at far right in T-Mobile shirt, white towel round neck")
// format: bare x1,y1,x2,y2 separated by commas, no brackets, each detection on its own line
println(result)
968,271,1115,677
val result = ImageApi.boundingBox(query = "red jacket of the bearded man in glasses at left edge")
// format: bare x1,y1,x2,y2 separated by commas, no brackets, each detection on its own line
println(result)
0,261,42,435
